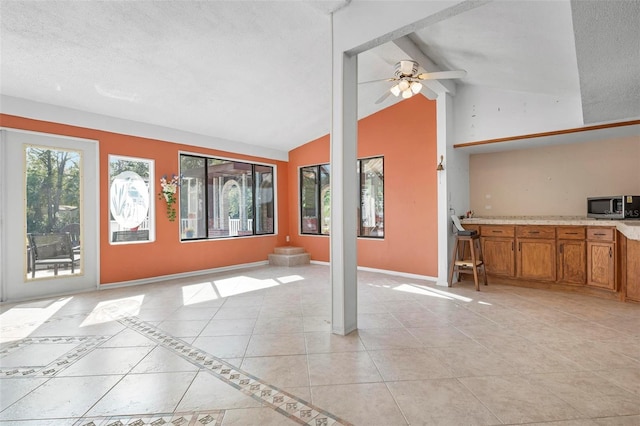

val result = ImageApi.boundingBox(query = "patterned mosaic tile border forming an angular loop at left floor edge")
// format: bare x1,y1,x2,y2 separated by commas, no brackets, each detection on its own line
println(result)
0,336,108,379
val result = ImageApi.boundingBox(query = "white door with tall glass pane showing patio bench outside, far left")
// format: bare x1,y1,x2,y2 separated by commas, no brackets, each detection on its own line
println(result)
0,129,99,301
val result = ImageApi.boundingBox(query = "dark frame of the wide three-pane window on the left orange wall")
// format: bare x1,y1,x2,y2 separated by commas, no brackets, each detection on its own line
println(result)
178,151,278,242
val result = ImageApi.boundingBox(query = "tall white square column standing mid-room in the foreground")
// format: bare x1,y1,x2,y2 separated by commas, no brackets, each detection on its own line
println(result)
331,29,359,335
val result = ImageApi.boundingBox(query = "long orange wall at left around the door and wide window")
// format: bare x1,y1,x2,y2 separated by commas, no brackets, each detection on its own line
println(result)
0,114,289,284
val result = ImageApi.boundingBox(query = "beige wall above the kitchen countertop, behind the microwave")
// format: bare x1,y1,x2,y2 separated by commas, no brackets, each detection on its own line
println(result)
469,136,640,217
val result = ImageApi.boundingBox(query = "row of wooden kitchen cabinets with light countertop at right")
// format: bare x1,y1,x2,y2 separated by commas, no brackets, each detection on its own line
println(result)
462,216,640,302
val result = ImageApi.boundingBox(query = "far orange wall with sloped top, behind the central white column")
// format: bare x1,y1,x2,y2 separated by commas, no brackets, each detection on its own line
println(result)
289,96,438,276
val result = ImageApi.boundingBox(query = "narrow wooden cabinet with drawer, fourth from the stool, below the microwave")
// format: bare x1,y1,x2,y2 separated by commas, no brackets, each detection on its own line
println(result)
587,227,616,291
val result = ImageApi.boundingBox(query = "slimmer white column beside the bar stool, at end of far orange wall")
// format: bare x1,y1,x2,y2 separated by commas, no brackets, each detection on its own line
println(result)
438,93,453,286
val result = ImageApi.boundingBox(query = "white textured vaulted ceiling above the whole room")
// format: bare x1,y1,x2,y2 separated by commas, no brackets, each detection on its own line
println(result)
0,0,640,151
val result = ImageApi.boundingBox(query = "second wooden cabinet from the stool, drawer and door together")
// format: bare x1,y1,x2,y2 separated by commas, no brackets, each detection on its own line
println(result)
516,226,556,281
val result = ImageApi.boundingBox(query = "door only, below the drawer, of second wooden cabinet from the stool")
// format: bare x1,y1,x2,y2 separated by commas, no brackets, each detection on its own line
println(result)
516,239,556,281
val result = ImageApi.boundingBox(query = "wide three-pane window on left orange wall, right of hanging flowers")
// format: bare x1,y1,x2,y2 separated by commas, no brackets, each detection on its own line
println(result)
180,154,275,240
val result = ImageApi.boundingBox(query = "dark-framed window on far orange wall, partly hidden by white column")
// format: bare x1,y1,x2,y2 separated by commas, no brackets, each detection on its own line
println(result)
300,157,384,238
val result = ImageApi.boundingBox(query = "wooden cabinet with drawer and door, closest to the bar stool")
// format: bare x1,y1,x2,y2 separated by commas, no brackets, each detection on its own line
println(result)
480,225,515,277
